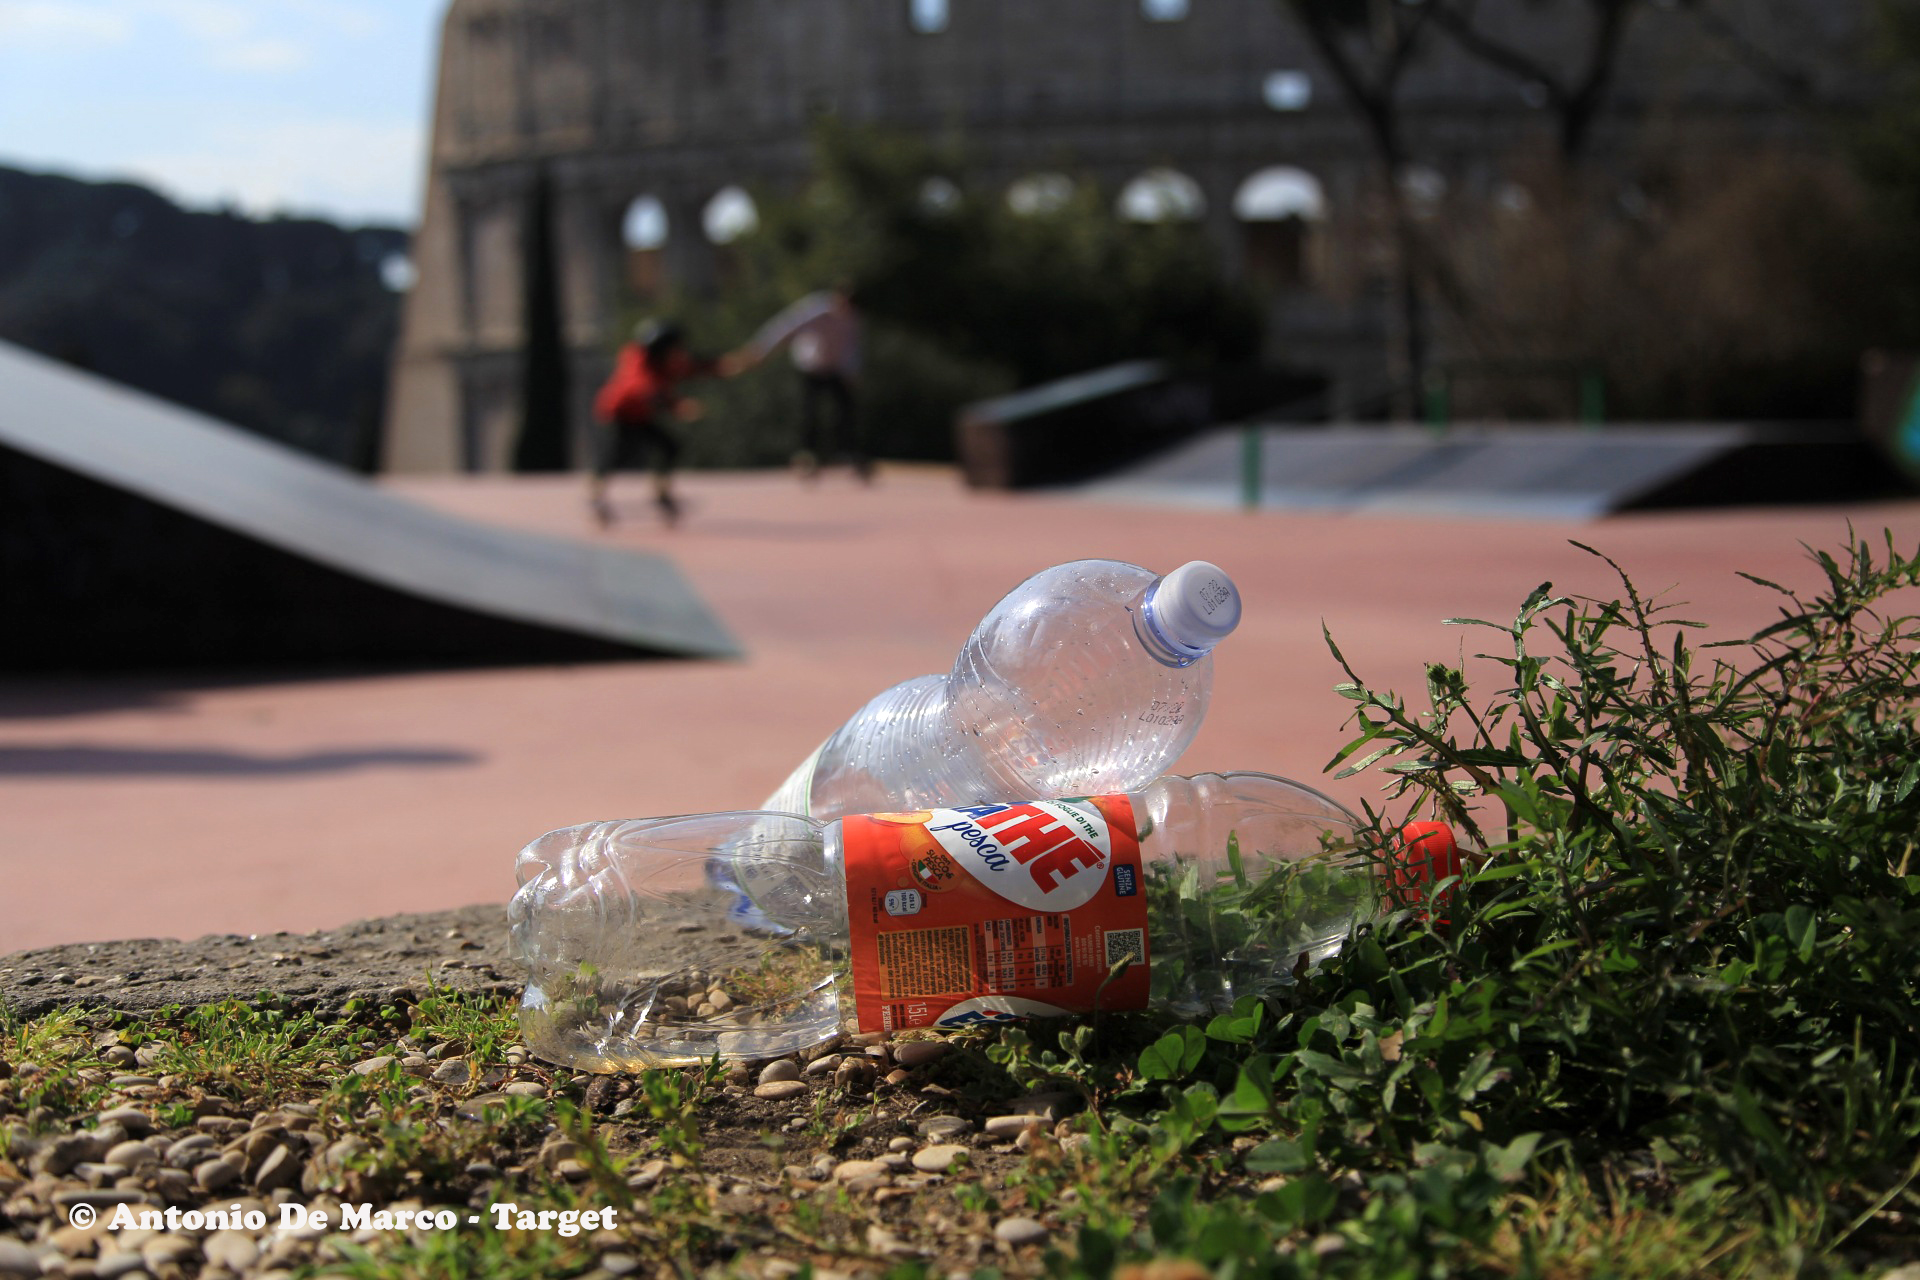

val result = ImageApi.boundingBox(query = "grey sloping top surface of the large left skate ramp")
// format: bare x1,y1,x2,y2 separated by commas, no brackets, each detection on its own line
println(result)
0,344,741,656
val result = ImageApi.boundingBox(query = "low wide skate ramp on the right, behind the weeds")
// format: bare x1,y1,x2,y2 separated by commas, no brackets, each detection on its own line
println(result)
1079,424,1895,520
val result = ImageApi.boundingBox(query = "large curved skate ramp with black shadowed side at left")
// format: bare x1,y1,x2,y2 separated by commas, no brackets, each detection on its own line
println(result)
0,344,739,670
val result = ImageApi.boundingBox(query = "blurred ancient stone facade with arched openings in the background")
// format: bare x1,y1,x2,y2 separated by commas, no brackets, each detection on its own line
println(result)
384,0,1870,470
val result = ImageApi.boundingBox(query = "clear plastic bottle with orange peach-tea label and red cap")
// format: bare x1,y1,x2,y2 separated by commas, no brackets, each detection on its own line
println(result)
507,773,1459,1071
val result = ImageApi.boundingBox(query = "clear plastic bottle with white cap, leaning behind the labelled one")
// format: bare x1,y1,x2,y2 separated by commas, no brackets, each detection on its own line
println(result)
762,560,1240,821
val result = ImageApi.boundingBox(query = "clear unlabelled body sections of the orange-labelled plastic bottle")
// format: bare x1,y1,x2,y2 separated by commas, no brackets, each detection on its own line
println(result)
509,773,1380,1071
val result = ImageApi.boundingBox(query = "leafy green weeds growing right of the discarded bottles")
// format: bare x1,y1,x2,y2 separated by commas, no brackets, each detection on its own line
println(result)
993,533,1920,1276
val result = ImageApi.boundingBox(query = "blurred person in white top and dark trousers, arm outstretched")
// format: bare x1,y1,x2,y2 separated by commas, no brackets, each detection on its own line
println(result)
735,284,874,480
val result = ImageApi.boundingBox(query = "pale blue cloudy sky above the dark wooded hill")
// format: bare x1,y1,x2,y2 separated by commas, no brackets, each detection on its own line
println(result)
0,0,445,226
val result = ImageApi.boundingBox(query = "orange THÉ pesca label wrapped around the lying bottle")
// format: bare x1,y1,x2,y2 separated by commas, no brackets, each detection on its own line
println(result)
841,796,1152,1031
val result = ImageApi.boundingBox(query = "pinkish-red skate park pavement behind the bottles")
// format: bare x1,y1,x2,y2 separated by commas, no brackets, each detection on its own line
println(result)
11,466,1920,952
